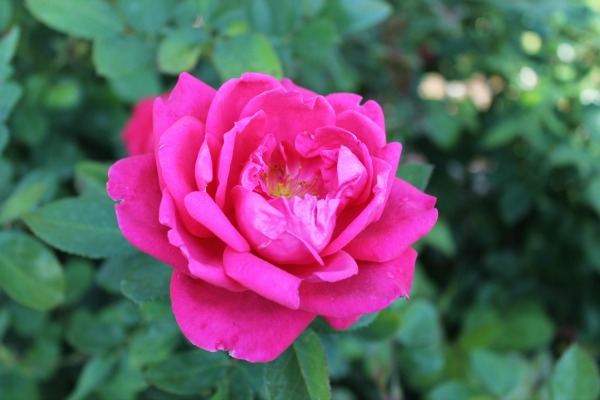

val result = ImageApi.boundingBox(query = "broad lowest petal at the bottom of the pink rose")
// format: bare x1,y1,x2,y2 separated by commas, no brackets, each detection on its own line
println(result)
171,273,315,362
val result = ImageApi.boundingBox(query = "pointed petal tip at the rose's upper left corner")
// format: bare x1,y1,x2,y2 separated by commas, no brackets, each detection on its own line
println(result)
167,72,217,122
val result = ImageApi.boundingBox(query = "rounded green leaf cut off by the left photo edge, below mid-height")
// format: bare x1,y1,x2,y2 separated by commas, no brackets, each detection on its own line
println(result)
0,232,65,310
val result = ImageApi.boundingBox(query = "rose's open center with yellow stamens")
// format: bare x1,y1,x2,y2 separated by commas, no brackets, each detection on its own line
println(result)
260,164,319,200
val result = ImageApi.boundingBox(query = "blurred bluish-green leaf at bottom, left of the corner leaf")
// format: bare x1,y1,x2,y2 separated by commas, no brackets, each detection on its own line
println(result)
470,349,523,397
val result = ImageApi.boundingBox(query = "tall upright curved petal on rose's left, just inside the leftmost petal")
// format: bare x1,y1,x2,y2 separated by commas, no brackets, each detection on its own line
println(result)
157,117,212,237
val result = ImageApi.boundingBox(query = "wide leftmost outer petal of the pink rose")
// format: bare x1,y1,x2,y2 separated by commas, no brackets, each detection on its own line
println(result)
106,154,187,271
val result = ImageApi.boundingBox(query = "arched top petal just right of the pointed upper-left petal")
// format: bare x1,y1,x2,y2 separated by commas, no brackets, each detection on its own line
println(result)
206,72,281,141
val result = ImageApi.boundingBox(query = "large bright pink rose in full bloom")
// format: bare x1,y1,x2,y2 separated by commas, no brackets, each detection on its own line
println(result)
107,73,437,362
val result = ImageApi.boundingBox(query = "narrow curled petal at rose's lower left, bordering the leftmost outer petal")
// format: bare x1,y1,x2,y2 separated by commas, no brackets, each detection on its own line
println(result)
159,190,246,292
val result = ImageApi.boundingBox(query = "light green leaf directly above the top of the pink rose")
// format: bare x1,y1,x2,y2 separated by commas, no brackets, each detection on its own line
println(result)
213,33,283,81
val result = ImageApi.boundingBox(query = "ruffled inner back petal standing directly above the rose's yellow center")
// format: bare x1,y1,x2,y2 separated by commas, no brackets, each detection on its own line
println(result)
240,88,335,143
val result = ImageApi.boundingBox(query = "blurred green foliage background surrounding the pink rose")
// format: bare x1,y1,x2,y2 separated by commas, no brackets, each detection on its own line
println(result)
0,0,600,400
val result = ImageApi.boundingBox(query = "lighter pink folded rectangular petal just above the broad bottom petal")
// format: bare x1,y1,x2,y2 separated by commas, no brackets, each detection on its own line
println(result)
223,247,302,310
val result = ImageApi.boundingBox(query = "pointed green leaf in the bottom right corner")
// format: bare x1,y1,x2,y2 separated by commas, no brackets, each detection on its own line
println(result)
549,344,600,400
